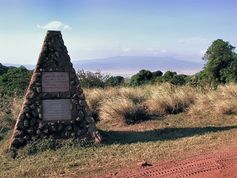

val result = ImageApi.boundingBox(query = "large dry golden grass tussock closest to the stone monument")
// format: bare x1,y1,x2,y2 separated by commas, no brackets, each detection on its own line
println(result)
85,87,145,124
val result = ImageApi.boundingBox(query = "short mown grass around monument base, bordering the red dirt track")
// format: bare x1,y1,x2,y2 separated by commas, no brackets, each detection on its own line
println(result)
0,114,237,178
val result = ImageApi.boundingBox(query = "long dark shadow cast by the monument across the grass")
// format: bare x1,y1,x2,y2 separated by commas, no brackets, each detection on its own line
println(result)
100,126,237,144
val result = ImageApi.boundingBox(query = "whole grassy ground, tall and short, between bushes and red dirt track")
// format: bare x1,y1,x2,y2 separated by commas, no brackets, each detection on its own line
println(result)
0,84,237,178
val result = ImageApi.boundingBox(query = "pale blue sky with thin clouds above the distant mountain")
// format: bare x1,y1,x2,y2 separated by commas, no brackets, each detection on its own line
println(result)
0,0,237,64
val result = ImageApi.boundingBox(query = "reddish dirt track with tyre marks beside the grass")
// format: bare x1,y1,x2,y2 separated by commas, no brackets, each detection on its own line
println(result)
97,149,237,178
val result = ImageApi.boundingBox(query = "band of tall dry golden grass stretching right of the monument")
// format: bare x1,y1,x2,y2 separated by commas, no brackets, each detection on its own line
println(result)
85,84,237,123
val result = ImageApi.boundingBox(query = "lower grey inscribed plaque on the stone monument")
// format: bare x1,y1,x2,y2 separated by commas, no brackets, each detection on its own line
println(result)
42,99,72,121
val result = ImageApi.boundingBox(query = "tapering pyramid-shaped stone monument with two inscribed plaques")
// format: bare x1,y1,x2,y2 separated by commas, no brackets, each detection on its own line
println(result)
10,31,101,149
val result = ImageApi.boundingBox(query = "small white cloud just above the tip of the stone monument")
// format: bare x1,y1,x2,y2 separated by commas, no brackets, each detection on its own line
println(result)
37,21,72,30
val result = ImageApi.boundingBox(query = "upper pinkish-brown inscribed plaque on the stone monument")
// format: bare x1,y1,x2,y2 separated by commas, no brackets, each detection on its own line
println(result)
42,72,69,92
